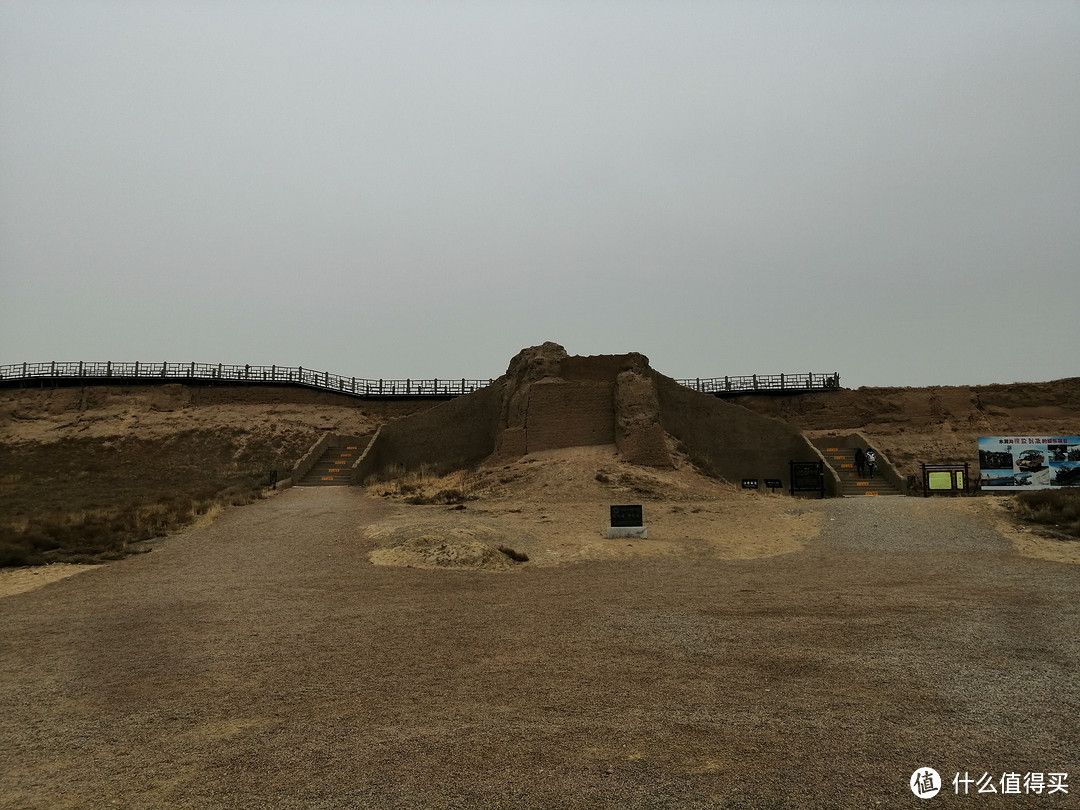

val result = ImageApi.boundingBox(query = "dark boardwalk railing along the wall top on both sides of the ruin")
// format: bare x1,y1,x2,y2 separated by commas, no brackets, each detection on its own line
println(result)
0,362,840,399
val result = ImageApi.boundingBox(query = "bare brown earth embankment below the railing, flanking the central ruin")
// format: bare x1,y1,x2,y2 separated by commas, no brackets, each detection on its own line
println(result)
6,377,1080,474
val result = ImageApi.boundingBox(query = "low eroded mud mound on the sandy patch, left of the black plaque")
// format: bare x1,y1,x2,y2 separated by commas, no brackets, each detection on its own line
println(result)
365,524,528,571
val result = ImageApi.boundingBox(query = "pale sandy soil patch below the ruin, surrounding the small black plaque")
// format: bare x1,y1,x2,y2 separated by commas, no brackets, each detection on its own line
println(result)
365,446,821,571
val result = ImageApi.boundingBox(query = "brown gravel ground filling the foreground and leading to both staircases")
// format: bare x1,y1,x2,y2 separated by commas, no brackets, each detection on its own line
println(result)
0,488,1080,809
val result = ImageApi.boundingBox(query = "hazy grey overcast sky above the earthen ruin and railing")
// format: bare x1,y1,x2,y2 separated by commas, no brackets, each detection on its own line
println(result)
0,0,1080,387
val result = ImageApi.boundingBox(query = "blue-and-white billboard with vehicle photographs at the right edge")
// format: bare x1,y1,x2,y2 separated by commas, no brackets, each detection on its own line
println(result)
978,436,1080,491
